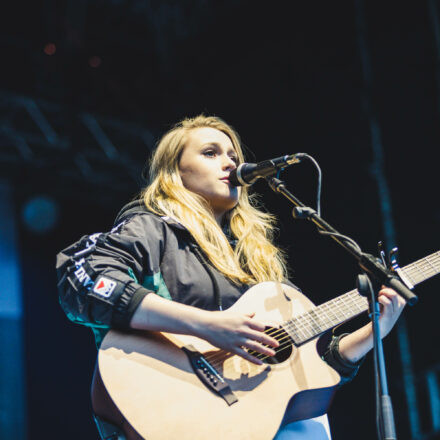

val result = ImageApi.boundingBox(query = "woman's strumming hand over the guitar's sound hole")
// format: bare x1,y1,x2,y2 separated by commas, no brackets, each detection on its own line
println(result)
196,311,279,365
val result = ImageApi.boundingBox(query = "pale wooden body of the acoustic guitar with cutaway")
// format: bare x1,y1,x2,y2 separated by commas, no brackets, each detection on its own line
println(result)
98,282,340,440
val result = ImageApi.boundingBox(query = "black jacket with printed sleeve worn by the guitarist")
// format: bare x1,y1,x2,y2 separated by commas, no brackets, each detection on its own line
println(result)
56,201,358,381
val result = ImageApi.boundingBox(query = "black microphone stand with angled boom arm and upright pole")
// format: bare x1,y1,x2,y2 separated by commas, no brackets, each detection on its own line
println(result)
265,176,418,440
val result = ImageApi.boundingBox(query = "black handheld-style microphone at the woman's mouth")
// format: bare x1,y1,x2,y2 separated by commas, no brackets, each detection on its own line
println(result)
229,153,305,186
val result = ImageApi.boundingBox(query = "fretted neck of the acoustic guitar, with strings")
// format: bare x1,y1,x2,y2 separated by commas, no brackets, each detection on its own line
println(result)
283,251,440,346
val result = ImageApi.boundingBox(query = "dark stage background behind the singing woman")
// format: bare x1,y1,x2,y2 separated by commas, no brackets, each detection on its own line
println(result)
0,0,440,440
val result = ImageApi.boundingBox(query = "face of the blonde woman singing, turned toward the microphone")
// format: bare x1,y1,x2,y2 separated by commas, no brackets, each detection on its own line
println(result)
179,127,240,223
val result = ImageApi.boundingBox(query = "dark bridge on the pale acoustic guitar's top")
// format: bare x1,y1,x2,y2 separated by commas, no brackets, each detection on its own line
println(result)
182,345,238,406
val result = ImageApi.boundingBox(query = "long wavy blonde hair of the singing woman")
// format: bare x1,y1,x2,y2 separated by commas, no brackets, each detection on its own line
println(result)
141,115,288,284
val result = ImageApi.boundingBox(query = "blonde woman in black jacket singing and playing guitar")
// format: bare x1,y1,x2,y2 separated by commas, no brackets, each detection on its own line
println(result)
57,115,405,440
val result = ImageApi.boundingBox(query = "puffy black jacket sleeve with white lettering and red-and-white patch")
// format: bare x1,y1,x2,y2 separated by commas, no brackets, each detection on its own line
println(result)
56,213,166,329
